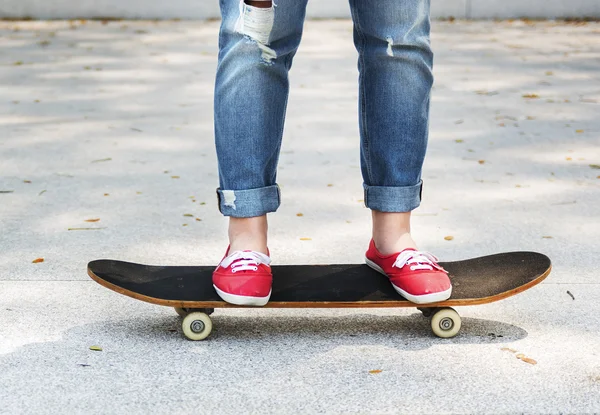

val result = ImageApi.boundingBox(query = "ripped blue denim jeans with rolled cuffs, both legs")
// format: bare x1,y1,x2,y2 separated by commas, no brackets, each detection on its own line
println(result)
214,0,433,217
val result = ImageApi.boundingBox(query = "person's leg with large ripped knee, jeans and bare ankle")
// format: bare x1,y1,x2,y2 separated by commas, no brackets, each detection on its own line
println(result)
215,0,307,253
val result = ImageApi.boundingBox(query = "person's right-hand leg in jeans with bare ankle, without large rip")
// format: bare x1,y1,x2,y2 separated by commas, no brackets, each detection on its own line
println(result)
350,0,433,254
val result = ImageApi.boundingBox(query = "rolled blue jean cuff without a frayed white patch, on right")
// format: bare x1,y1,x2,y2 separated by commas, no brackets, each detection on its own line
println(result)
363,180,423,212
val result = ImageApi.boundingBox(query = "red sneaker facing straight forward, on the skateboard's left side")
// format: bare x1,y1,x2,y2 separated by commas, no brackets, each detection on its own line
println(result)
213,248,273,306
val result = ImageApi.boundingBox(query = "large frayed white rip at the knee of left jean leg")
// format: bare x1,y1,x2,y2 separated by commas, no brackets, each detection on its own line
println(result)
235,0,277,63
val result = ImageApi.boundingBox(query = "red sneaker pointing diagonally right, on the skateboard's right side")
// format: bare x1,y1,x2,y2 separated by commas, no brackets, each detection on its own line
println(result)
366,240,452,304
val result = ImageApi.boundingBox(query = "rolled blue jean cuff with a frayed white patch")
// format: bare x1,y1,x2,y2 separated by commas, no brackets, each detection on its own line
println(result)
217,184,281,218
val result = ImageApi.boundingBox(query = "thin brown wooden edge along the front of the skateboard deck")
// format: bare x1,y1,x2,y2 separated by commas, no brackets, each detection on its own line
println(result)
88,265,552,308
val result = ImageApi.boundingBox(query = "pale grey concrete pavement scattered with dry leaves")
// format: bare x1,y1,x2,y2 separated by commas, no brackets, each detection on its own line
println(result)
0,20,600,414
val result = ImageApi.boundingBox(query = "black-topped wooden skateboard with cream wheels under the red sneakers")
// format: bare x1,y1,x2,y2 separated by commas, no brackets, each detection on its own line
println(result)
88,252,552,340
